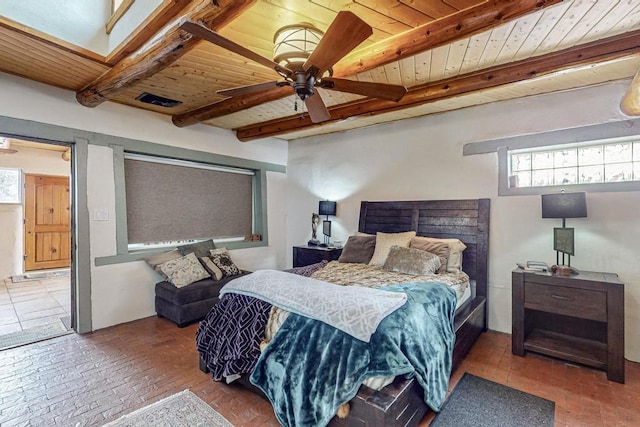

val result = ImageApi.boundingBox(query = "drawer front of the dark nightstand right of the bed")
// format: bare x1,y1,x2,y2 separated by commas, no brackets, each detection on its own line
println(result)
524,283,607,322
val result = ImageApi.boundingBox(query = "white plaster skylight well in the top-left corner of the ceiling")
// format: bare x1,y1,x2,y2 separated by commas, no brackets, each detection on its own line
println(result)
0,0,109,55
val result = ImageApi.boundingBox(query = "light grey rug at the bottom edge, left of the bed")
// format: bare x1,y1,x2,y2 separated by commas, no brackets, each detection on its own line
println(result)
104,390,233,427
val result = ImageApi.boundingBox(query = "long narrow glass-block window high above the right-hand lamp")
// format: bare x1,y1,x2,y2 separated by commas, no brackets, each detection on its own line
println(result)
508,137,640,188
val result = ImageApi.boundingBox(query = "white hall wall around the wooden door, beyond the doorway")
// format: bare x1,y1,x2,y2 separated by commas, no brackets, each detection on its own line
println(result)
0,146,71,279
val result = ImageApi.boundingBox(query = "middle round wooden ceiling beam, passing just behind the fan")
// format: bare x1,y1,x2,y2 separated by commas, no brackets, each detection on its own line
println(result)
172,0,563,127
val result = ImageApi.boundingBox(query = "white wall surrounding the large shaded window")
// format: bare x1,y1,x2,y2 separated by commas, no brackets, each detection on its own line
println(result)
0,73,287,329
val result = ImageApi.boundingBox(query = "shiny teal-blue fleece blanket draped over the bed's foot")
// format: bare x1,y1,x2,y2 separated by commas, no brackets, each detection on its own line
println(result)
251,282,456,426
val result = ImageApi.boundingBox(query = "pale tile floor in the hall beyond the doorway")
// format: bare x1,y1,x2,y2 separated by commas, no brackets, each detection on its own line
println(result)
0,276,71,335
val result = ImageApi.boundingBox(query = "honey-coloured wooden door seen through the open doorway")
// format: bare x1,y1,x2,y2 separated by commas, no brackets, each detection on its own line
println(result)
24,174,71,271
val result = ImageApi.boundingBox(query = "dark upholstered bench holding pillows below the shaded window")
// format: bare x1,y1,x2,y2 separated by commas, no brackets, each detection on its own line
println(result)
156,271,250,328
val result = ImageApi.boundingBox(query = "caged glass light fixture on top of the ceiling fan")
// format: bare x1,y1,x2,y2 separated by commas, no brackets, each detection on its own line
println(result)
273,22,324,71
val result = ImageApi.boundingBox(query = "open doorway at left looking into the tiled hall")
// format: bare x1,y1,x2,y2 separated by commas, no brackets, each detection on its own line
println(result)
0,139,75,350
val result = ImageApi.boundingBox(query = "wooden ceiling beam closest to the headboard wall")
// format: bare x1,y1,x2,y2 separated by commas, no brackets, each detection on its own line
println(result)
235,30,640,141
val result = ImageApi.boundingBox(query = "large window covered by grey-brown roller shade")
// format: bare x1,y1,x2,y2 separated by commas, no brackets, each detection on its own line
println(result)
124,153,256,250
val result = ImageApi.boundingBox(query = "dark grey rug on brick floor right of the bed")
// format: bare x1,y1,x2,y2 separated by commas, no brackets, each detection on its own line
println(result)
431,373,556,427
